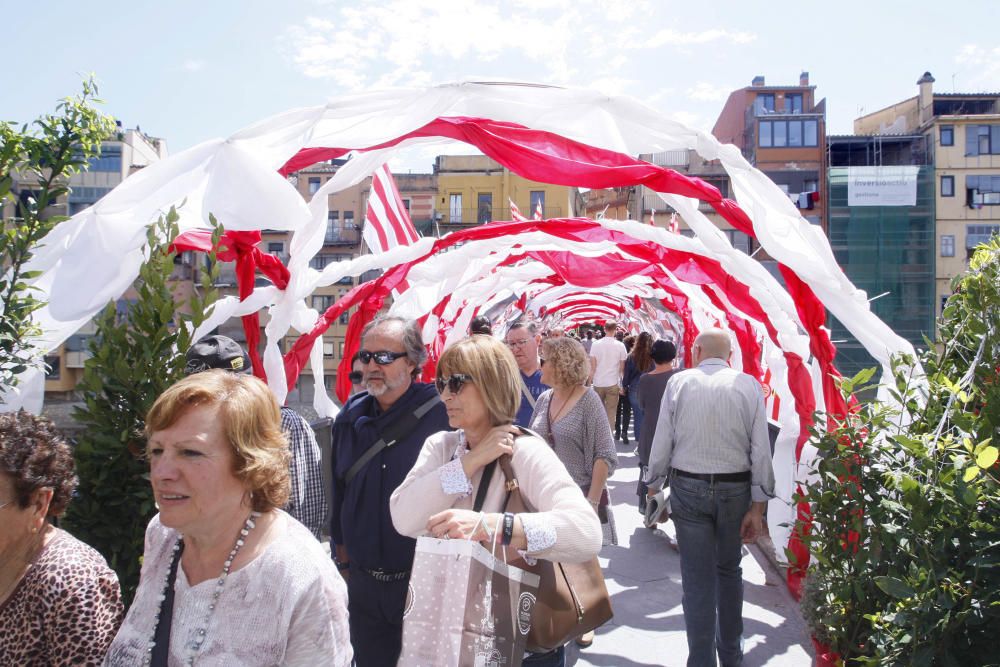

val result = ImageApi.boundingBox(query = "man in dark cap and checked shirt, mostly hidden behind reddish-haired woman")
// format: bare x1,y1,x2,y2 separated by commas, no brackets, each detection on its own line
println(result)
184,335,328,539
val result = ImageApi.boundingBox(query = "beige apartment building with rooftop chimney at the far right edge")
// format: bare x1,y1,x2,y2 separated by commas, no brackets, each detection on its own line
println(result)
854,72,1000,315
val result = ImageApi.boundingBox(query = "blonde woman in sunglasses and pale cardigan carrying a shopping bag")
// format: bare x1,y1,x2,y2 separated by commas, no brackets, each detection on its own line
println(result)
389,336,601,667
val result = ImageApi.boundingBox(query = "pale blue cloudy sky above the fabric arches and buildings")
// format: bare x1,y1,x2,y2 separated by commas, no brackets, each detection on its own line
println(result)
9,0,1000,170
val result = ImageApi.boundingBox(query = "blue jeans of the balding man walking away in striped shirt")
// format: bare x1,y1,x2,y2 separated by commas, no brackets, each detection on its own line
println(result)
670,471,750,667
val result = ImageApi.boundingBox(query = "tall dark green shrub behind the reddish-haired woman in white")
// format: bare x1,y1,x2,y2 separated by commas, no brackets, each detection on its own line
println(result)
66,209,222,603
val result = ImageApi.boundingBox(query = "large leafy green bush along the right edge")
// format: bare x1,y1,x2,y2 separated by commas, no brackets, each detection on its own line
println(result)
802,238,1000,666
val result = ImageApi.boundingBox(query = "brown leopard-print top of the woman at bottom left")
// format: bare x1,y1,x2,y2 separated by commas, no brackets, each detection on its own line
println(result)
0,529,124,667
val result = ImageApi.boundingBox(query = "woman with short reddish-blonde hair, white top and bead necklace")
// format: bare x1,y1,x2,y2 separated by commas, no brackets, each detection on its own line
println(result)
105,370,352,666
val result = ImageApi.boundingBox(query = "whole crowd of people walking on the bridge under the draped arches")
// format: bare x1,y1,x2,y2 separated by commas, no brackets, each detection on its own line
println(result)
0,316,774,667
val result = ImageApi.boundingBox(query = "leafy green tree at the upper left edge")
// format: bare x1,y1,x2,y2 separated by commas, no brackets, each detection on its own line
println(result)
0,78,115,388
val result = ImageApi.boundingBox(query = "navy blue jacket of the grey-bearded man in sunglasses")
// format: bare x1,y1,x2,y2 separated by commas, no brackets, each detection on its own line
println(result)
330,382,449,572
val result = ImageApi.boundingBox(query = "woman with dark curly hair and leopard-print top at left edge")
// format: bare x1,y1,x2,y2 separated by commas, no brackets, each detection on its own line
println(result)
0,411,124,666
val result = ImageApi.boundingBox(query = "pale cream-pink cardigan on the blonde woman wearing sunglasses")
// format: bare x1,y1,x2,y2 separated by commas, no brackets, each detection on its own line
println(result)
389,431,601,563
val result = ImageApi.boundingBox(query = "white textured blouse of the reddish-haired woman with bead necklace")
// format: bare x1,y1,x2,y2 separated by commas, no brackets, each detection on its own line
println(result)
104,510,353,667
